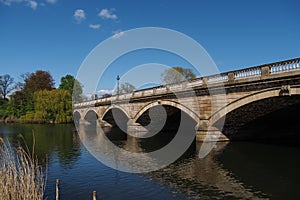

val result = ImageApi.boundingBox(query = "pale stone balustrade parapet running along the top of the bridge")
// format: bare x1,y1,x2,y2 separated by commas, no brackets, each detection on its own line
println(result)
74,58,300,108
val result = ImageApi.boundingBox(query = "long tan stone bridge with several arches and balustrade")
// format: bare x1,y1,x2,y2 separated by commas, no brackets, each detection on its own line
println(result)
73,58,300,141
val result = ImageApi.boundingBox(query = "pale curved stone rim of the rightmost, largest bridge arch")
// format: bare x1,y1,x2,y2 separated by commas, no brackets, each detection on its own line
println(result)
209,88,300,125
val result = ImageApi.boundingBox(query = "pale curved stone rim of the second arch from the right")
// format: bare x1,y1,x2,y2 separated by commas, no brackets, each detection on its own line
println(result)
133,100,200,123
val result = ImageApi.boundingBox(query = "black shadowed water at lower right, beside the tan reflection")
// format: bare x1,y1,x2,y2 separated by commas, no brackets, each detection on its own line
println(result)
217,142,300,199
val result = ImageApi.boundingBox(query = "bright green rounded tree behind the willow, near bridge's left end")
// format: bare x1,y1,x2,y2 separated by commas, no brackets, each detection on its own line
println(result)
58,74,82,102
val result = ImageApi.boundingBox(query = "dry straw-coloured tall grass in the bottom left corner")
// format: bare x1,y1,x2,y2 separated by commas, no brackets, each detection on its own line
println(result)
0,138,45,200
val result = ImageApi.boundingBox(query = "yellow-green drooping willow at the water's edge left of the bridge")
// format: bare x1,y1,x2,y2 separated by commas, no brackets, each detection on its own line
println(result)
33,89,72,123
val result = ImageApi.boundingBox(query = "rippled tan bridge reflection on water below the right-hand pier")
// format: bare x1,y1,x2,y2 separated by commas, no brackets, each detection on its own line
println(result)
151,143,267,199
